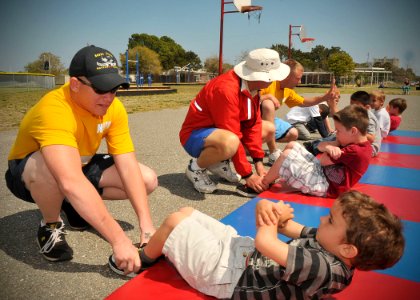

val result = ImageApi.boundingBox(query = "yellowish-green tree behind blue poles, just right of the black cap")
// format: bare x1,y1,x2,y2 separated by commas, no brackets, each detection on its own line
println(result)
120,46,162,74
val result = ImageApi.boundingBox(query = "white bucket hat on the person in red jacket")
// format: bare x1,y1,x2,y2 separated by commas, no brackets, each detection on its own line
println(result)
233,48,290,82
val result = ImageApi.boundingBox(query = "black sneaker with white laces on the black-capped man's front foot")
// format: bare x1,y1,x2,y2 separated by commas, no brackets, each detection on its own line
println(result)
37,222,73,261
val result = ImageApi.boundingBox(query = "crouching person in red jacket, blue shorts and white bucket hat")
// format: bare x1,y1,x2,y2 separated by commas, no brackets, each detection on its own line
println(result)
179,49,290,193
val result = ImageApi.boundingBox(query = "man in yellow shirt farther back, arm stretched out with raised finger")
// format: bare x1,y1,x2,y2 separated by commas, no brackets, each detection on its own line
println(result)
260,59,340,164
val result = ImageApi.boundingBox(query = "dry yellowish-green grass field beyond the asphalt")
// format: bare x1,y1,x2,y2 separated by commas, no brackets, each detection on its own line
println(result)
0,85,420,131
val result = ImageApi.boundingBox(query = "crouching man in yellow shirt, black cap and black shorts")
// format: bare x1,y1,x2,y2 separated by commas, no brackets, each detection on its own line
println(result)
6,46,157,272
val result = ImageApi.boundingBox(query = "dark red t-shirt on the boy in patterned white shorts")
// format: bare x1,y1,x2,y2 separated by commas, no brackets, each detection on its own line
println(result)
324,141,372,198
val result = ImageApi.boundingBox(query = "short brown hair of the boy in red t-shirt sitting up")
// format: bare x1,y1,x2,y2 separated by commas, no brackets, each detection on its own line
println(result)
333,104,369,135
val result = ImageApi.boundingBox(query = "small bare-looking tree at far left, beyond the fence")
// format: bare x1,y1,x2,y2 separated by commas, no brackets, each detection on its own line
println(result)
25,52,67,76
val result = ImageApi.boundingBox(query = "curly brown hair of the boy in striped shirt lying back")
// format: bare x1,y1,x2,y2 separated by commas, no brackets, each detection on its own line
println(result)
337,190,405,271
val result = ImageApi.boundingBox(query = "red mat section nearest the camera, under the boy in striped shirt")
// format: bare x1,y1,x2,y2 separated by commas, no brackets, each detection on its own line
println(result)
106,261,420,300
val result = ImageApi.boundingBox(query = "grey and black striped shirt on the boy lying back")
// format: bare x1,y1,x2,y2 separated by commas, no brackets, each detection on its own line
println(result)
232,227,353,300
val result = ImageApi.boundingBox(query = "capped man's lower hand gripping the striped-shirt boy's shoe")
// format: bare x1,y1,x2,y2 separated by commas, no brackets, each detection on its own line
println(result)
112,238,141,275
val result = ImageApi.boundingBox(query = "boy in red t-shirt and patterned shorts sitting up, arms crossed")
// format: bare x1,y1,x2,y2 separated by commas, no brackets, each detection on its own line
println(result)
263,105,372,197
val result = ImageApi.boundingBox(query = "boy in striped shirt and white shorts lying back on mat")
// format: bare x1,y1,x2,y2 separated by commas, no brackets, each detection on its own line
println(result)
109,191,404,299
